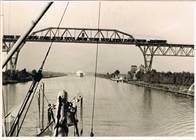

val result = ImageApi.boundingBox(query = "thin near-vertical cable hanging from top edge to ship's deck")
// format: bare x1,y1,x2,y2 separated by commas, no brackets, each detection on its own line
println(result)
90,1,101,137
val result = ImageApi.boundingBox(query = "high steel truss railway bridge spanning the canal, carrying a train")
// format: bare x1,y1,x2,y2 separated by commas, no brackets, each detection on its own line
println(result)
3,27,194,70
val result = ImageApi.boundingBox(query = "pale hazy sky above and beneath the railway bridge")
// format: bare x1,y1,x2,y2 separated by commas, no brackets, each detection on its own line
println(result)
3,1,194,73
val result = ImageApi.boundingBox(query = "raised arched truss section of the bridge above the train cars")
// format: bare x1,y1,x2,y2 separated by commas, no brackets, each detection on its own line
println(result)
32,27,134,43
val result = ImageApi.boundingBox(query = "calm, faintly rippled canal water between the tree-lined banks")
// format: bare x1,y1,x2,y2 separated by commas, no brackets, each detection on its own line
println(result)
3,76,194,136
